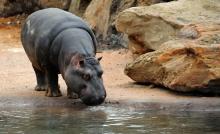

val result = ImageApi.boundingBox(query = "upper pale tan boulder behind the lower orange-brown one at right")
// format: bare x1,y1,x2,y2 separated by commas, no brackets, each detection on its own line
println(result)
116,0,220,55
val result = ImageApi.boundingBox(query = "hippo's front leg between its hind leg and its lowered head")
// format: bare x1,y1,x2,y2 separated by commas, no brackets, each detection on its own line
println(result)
46,68,62,97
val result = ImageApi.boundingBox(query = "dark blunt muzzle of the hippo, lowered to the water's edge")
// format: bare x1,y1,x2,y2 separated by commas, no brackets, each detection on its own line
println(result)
80,89,106,106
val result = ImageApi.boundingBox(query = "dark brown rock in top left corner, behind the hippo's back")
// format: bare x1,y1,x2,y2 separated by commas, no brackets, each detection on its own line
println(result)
0,0,71,17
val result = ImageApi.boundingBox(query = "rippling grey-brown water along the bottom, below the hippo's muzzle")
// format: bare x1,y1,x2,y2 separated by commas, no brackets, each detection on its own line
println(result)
0,106,220,134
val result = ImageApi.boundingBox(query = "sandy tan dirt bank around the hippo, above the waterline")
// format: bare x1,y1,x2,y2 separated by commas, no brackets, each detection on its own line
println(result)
0,20,220,110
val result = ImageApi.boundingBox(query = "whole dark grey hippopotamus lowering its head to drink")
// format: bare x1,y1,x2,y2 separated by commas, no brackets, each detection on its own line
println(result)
21,8,106,105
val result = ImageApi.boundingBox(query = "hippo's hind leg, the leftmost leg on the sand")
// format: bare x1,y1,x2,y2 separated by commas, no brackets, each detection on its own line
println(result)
33,66,48,91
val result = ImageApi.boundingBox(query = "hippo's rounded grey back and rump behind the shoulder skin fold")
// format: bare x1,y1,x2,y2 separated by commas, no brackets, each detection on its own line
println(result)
21,8,97,68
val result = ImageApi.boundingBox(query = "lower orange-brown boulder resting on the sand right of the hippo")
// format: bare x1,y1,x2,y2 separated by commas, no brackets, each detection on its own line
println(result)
125,40,220,93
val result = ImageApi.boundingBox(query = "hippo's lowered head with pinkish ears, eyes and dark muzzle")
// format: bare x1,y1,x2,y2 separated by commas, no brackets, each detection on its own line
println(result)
64,56,106,106
